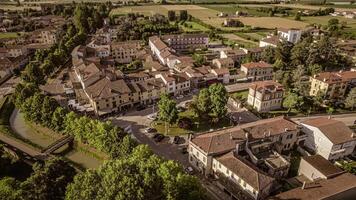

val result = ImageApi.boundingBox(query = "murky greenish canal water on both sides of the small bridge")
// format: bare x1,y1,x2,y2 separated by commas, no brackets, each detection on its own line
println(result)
10,109,103,168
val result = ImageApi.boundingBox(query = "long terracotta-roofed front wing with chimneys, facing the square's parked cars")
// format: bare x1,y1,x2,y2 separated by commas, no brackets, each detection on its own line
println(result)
188,117,304,175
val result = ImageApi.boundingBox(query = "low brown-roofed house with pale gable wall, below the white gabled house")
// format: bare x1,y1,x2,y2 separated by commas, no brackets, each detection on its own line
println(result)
298,154,344,181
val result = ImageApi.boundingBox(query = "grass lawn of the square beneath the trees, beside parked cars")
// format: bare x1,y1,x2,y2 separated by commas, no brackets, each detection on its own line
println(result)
152,110,231,136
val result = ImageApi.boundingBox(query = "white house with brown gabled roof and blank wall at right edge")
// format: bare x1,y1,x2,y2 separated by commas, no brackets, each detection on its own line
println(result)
301,117,356,161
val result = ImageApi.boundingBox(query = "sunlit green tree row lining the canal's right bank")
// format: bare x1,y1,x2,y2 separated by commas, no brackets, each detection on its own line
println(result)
13,84,134,157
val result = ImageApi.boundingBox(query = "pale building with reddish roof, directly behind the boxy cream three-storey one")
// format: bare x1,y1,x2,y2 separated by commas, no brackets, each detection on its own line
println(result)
240,61,273,81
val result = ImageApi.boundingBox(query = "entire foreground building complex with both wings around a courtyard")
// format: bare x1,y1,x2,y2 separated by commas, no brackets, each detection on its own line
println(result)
188,117,305,199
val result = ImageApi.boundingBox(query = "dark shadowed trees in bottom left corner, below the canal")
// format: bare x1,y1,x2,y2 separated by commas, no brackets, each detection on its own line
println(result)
0,155,76,200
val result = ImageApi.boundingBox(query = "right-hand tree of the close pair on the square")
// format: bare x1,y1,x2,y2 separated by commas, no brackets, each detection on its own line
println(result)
209,83,228,121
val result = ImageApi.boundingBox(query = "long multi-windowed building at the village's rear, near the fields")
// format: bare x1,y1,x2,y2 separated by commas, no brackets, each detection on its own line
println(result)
161,34,209,51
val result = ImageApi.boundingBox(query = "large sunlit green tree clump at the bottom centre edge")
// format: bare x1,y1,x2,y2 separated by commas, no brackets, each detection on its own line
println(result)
66,145,205,200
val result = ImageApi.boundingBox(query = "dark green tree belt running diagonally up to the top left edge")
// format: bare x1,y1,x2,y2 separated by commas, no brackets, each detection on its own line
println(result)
21,3,109,84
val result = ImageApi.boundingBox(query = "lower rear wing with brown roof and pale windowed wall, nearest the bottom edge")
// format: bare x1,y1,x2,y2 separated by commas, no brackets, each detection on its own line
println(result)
212,152,275,199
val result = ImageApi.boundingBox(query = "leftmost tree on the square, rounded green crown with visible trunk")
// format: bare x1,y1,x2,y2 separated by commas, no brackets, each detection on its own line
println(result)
158,94,178,134
